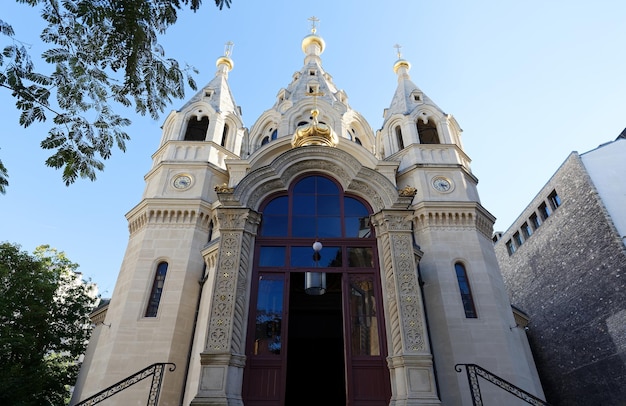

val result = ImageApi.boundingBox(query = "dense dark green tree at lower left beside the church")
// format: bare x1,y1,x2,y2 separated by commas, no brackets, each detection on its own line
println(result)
0,243,96,406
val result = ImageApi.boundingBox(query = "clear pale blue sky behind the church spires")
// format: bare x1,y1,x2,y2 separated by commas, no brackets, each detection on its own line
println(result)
0,0,626,297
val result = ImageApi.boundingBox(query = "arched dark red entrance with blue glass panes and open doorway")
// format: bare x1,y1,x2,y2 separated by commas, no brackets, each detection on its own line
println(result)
243,175,391,406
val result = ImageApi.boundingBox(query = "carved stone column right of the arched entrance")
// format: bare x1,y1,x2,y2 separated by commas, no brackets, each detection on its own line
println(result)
372,210,441,406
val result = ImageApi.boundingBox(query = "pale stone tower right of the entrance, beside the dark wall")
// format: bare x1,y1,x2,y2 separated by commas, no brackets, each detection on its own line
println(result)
377,52,543,405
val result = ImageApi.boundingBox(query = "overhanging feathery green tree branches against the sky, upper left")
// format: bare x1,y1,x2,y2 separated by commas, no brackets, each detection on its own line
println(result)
0,0,231,193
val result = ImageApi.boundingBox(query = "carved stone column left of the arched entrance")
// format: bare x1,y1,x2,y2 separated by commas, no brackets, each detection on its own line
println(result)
191,205,260,405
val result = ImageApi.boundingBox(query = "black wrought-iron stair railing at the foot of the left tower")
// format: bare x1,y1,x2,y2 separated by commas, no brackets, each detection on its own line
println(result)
75,362,176,406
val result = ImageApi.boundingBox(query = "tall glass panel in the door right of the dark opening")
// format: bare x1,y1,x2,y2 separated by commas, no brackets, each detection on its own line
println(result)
350,275,380,356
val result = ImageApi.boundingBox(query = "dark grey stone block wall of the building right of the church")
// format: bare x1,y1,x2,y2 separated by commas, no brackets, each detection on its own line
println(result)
495,153,626,406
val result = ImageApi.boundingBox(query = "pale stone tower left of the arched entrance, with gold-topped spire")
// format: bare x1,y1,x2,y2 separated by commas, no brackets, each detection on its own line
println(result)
75,48,245,405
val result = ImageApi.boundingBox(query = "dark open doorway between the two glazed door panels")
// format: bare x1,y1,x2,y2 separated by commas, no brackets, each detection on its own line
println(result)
285,272,346,406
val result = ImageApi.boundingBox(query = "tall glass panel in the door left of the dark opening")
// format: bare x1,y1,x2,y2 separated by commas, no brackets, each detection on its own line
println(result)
253,274,285,355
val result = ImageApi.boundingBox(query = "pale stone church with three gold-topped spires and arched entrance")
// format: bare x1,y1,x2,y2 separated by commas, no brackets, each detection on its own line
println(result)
74,23,543,406
